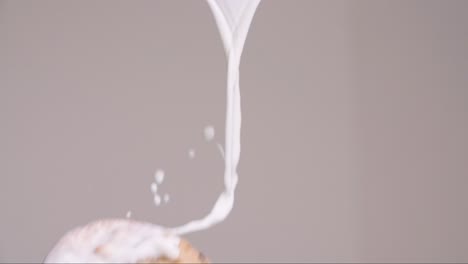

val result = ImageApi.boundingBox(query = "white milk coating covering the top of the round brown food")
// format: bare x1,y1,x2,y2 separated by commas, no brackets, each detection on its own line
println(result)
45,220,180,263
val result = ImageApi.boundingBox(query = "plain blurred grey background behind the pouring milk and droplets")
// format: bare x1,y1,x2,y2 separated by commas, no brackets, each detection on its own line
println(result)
0,0,468,262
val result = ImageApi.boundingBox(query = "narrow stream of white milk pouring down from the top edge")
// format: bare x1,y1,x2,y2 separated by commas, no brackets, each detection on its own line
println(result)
172,0,260,235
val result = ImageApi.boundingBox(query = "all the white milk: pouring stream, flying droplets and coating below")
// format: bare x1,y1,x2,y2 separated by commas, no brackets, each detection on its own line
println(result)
45,0,260,263
